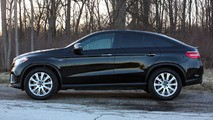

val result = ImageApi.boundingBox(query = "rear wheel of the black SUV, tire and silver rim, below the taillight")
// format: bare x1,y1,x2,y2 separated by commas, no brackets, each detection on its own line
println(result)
148,68,182,100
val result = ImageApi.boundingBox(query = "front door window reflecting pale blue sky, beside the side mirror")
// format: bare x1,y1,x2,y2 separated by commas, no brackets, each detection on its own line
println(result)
82,34,114,50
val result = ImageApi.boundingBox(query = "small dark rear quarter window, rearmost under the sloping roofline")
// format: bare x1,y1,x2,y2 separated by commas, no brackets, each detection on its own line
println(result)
151,36,175,47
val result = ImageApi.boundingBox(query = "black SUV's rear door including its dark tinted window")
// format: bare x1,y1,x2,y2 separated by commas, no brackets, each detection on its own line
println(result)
114,32,160,83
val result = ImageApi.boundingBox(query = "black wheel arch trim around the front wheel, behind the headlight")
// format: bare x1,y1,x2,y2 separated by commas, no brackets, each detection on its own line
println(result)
21,63,62,90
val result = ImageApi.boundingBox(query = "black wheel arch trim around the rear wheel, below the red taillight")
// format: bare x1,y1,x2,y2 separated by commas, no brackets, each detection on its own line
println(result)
146,63,186,85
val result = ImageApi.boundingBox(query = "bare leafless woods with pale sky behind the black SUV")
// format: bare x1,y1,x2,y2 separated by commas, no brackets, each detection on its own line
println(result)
0,0,213,70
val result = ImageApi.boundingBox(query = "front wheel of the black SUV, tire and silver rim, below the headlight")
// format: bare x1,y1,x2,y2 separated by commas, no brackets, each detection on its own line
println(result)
24,68,58,100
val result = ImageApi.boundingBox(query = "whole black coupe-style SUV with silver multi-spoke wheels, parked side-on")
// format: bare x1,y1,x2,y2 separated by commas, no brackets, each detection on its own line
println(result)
10,30,203,100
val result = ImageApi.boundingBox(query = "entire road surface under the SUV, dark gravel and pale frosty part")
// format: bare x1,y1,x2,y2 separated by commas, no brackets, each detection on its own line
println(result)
0,84,213,120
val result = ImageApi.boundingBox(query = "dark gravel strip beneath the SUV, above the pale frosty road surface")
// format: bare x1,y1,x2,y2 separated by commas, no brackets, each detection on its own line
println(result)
0,84,213,113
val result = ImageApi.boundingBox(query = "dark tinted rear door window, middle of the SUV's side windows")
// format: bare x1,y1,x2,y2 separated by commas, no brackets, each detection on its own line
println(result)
116,33,155,48
